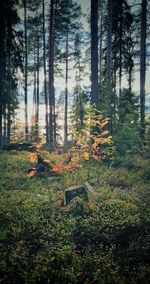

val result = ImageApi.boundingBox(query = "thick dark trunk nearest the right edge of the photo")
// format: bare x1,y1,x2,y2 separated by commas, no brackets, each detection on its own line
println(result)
140,0,147,138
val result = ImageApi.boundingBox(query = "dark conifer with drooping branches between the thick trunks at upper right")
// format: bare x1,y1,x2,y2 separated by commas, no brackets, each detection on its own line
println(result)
112,0,133,96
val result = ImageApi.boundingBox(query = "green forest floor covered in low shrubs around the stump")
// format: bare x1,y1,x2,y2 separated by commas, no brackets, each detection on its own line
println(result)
0,151,150,284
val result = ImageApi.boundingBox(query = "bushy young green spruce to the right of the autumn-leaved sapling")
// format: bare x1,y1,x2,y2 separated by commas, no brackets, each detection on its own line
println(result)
113,89,140,156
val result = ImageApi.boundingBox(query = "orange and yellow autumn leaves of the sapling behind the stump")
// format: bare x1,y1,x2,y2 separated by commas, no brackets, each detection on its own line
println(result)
28,109,113,177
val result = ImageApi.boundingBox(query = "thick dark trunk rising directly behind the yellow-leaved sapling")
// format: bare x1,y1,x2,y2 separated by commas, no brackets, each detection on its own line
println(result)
91,0,99,108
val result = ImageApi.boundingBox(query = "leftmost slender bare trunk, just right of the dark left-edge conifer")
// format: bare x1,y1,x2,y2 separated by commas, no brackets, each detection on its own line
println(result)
24,0,29,141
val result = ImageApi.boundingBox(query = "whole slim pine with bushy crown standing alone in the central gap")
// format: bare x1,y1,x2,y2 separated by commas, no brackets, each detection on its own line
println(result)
54,0,81,145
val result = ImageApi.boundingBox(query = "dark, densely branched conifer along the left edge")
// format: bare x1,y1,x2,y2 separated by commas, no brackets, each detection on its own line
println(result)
0,0,22,148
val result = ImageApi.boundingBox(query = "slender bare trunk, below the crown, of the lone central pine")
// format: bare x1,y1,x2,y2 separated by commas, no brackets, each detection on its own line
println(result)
64,27,68,145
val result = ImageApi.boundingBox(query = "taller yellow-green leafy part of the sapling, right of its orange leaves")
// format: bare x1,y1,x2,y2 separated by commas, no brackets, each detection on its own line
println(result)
71,105,114,161
